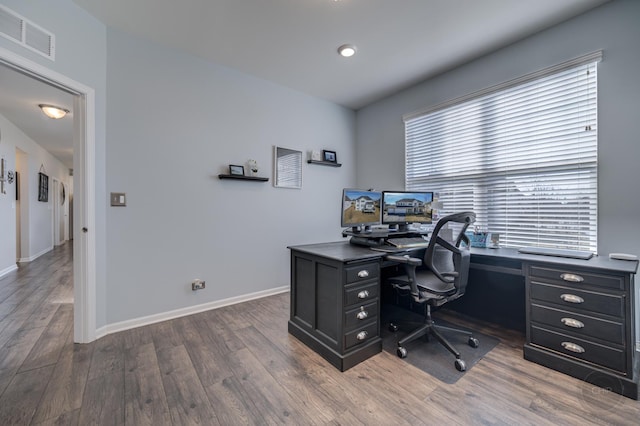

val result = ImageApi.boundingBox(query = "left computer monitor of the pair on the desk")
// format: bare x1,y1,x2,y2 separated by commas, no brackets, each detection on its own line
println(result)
340,188,382,233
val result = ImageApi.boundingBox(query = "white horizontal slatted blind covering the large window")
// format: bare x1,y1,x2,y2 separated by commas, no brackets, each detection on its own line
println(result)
404,52,601,252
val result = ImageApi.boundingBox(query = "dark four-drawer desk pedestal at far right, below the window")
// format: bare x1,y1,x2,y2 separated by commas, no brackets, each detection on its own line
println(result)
523,260,639,399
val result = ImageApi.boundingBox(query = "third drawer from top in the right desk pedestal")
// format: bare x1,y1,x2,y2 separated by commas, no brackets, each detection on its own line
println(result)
531,304,624,345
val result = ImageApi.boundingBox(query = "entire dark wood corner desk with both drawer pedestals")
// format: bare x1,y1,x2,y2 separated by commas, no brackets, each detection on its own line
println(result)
288,241,640,399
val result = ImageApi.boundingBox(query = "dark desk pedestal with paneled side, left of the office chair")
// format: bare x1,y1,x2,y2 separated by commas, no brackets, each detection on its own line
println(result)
289,244,382,371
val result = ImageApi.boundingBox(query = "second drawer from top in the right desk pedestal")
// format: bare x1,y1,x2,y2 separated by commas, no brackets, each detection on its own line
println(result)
530,282,624,318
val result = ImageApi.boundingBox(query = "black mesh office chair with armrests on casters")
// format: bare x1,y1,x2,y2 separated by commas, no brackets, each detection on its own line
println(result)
387,212,479,371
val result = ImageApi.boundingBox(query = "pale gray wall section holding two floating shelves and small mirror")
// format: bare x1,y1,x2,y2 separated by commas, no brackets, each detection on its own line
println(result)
107,30,355,323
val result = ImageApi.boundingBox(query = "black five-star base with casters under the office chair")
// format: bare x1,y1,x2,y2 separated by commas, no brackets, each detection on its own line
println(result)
389,305,480,371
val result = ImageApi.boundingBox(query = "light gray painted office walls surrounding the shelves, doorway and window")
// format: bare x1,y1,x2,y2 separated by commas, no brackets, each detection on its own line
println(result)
0,0,640,338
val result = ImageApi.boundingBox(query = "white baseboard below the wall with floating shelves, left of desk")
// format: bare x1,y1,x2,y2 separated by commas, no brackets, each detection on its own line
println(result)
96,285,290,339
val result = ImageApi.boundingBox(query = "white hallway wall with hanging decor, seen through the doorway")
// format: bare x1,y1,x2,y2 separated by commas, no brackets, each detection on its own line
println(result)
0,115,69,275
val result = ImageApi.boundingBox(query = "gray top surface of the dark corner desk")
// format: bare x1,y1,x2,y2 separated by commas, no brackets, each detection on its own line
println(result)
287,241,638,274
